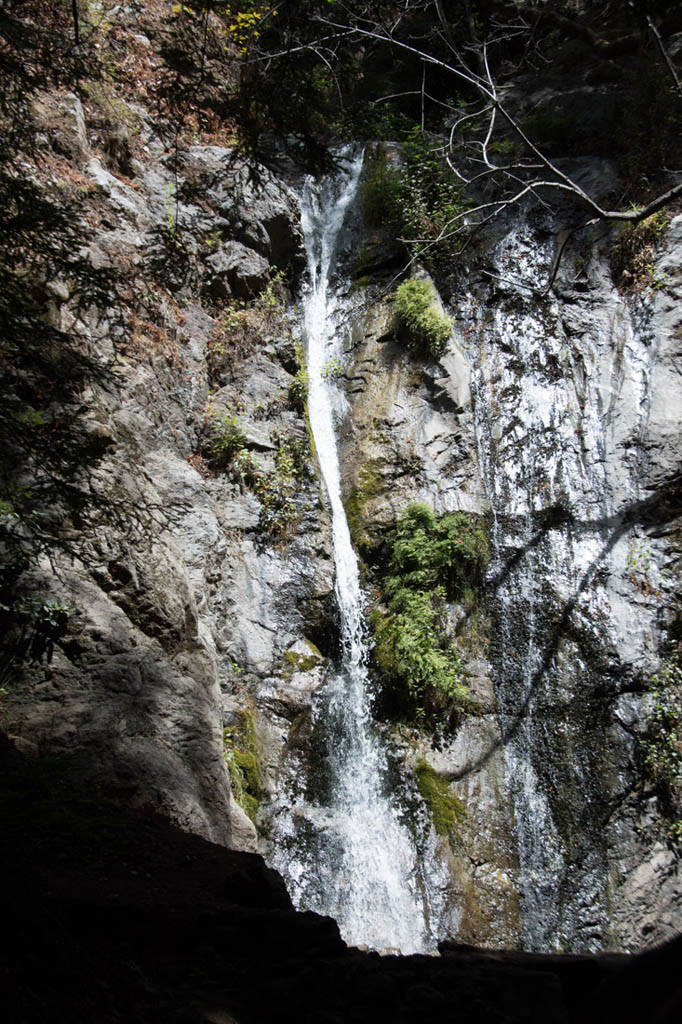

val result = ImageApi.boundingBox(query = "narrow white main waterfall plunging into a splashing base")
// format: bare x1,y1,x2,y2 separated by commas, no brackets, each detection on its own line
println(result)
272,153,435,953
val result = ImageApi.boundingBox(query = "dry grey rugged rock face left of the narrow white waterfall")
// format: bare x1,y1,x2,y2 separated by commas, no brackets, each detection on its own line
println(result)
8,83,331,850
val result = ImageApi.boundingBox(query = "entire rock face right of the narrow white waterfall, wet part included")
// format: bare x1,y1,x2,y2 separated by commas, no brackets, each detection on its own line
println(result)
290,151,682,950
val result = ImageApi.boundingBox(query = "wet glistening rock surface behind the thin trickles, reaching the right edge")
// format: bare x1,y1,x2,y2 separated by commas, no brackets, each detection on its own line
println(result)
450,207,680,949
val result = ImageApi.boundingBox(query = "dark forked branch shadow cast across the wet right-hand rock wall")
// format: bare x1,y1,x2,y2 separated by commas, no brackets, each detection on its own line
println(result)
444,473,682,782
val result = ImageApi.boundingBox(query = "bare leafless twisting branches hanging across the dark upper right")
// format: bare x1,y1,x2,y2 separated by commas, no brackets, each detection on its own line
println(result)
237,0,682,289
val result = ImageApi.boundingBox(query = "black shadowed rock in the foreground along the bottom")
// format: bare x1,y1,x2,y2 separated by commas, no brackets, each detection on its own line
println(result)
0,742,682,1024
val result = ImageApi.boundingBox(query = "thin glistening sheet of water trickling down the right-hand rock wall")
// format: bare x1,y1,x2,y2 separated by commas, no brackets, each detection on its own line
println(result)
469,230,651,950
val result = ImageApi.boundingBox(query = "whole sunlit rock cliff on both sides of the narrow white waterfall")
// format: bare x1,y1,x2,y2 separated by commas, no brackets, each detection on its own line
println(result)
6,68,682,950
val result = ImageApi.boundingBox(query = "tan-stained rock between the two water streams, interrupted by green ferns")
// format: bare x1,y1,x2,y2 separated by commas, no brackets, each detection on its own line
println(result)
333,274,520,947
